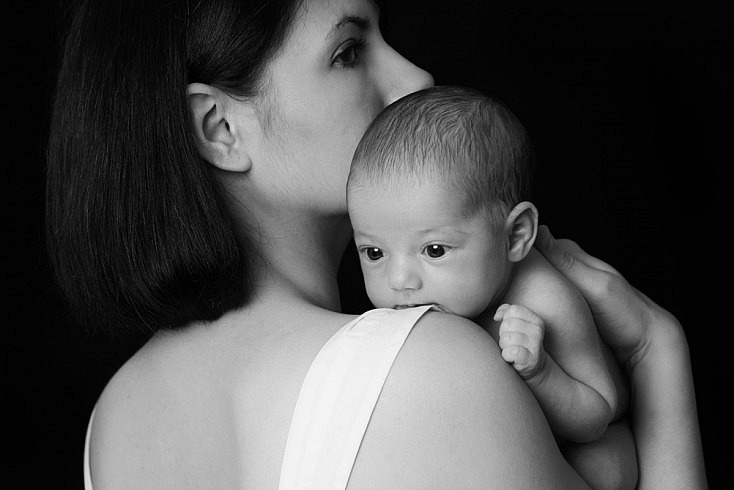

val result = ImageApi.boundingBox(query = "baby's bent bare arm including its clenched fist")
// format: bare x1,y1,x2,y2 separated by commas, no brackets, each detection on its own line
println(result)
490,250,618,442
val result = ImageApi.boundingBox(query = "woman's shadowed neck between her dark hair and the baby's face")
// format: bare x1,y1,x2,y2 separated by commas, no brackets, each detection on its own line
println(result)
247,210,351,311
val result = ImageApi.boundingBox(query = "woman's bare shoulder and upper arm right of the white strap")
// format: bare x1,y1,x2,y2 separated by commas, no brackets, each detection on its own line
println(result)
350,312,583,489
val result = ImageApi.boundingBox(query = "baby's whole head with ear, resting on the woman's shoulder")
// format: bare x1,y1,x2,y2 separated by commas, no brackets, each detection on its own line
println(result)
347,86,537,318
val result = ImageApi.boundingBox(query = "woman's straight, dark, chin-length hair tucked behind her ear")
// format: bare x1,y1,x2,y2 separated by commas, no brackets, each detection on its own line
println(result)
46,0,299,333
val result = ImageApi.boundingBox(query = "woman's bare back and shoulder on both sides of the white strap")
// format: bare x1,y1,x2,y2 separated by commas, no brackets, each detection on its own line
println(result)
90,294,584,490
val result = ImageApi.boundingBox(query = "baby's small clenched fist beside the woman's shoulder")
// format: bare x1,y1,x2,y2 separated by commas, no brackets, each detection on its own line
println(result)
494,304,545,381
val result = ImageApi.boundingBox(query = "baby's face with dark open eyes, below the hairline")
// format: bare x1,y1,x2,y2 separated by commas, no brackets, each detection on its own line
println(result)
348,183,511,318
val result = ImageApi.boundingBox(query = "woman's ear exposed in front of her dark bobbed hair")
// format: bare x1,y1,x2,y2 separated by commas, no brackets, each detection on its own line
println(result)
186,83,252,172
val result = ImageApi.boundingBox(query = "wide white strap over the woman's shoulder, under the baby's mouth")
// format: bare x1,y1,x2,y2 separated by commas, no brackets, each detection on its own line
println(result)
279,305,432,490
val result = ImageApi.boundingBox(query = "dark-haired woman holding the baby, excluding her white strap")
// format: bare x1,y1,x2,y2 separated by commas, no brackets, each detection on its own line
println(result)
48,0,703,489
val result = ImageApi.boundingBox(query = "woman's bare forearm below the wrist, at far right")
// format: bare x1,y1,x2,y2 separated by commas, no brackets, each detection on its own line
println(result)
629,313,707,490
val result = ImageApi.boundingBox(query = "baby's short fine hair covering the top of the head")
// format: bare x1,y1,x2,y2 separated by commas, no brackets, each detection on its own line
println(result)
347,86,535,216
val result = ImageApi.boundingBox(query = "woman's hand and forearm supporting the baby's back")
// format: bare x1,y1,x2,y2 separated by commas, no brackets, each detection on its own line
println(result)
535,226,707,489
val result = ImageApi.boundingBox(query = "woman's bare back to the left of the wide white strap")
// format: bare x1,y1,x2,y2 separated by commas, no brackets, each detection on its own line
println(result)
90,300,351,490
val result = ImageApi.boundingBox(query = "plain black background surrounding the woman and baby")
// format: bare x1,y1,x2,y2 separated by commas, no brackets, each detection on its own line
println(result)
7,0,734,488
